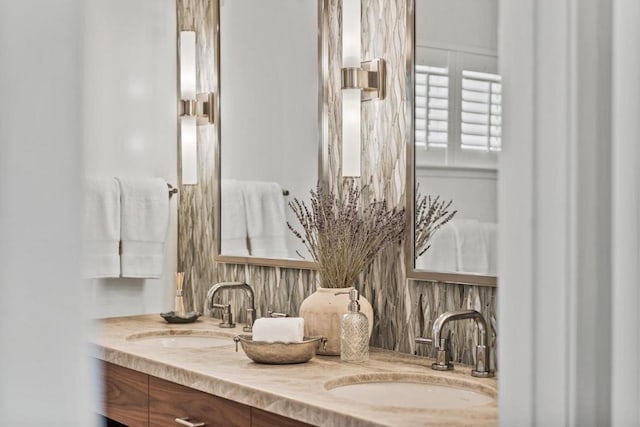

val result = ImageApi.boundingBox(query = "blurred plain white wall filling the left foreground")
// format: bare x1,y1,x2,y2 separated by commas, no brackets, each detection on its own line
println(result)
0,0,93,426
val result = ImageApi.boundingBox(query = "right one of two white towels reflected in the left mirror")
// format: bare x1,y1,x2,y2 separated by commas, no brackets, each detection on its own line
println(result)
244,181,289,258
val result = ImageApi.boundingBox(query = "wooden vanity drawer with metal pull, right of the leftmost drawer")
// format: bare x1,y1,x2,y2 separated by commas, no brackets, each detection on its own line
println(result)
149,377,251,427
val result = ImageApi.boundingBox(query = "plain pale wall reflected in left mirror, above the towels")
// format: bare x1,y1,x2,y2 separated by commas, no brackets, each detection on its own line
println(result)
220,0,320,258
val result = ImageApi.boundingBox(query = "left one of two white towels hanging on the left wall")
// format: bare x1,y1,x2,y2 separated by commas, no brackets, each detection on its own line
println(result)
84,177,120,278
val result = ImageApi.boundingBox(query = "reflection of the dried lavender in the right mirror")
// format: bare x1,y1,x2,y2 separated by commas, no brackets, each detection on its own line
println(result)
415,193,458,258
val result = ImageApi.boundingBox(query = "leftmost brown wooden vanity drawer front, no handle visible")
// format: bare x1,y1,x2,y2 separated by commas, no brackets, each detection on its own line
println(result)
100,362,149,427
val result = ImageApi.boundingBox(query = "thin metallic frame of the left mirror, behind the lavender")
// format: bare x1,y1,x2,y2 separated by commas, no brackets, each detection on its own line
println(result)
213,0,329,270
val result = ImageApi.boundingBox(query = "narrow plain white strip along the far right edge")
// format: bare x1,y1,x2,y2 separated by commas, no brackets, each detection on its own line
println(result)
610,0,640,427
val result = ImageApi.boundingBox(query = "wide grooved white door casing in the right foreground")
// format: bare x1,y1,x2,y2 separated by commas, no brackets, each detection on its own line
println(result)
498,0,616,427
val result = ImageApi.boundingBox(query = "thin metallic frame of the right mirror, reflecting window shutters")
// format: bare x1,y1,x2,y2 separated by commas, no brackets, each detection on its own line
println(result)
405,0,498,286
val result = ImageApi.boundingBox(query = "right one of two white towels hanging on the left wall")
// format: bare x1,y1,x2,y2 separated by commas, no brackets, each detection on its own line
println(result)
118,178,169,278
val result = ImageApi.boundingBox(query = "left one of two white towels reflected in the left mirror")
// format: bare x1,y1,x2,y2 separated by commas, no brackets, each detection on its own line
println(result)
220,179,249,256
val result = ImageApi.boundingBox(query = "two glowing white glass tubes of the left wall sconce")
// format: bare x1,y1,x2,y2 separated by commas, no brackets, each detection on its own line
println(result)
180,31,198,185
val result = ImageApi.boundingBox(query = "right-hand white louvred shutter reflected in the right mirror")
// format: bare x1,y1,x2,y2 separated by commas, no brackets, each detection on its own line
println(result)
460,70,502,151
